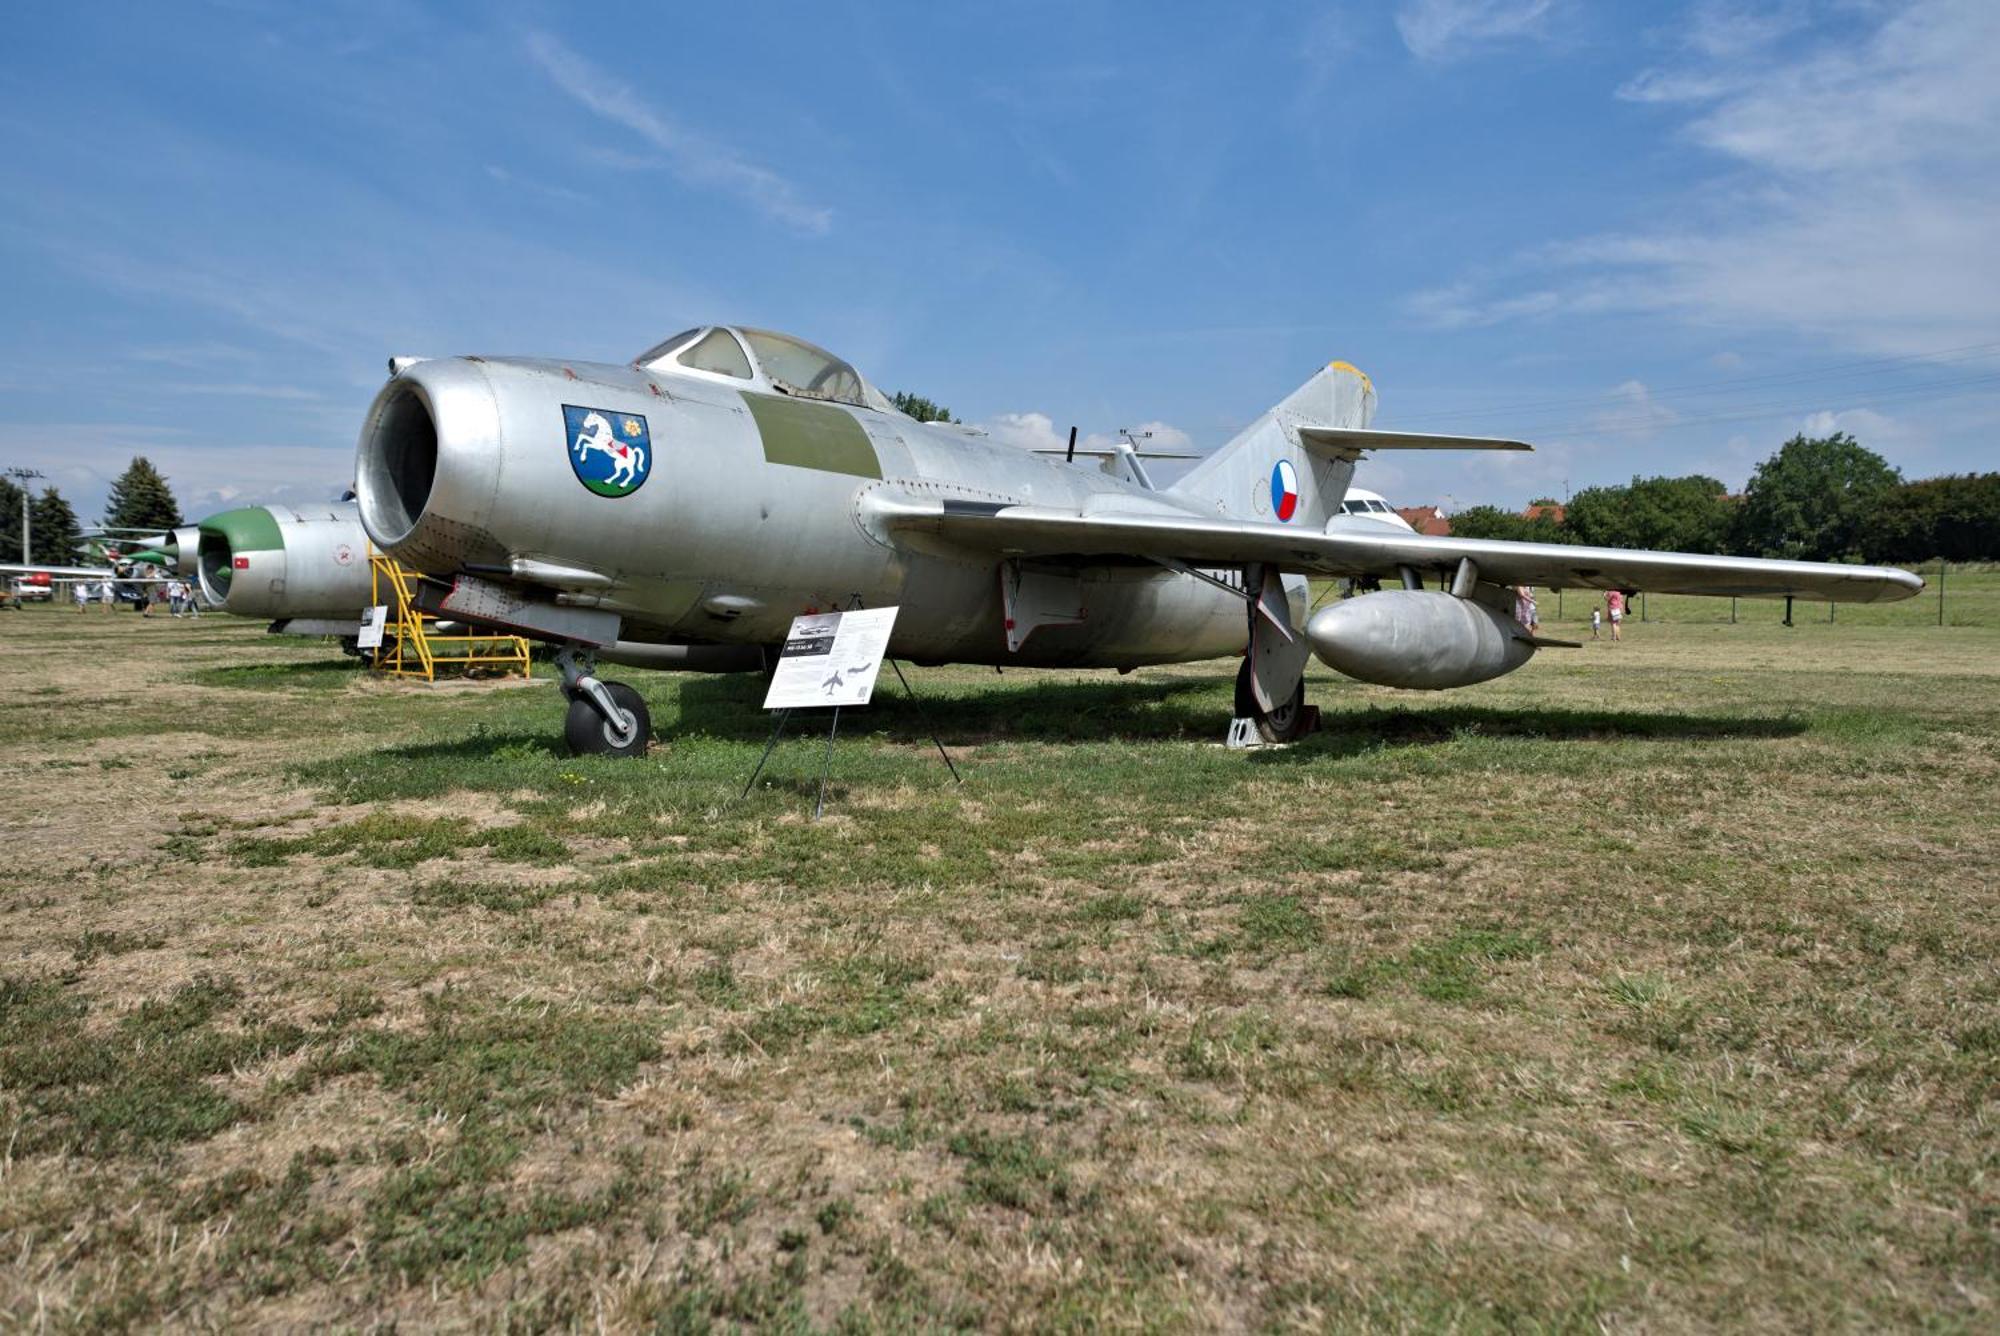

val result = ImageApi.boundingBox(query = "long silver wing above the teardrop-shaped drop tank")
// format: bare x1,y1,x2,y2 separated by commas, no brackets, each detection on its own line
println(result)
874,500,1924,602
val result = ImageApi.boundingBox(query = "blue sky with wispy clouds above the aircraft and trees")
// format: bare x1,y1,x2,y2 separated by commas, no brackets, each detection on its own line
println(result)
0,0,2000,516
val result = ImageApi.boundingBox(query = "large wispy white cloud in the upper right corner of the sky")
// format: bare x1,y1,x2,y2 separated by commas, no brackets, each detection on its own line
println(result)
1408,0,2000,352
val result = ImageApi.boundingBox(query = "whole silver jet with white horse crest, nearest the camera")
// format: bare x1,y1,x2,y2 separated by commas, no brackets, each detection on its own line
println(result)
356,326,1922,754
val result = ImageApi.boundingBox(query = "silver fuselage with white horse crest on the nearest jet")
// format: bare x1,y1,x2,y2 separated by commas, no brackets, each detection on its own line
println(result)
362,358,1246,668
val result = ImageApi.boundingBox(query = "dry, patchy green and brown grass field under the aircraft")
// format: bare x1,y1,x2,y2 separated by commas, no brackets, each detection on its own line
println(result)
0,572,2000,1330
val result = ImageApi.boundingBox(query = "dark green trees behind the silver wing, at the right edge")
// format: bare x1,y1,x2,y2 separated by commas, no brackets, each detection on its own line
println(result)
1450,432,2000,564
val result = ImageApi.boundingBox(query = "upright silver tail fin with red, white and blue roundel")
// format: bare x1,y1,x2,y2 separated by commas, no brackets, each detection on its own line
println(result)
1168,362,1374,530
